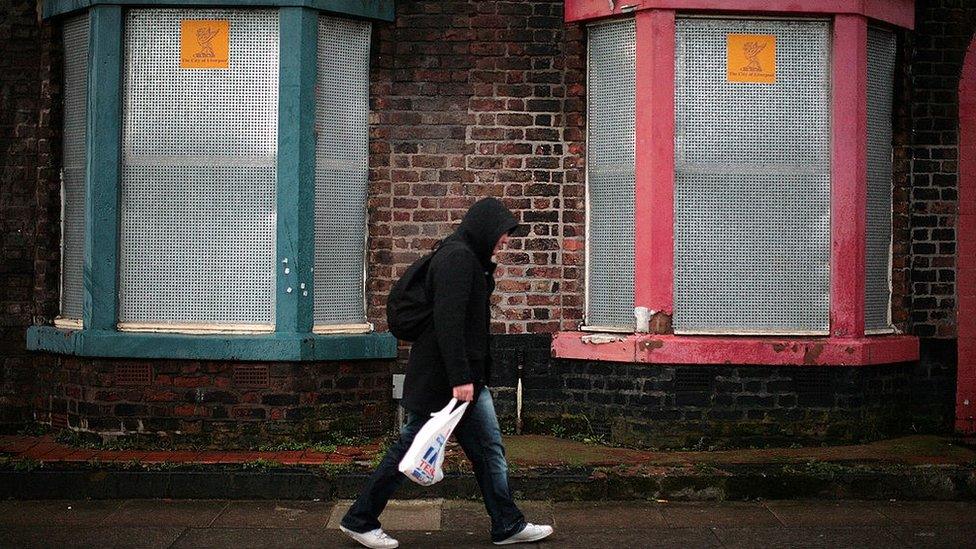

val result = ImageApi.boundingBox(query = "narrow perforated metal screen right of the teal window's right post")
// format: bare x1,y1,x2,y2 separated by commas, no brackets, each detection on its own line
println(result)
313,16,370,326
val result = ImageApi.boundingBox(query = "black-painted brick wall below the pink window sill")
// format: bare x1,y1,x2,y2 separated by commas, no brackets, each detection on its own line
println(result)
494,335,955,449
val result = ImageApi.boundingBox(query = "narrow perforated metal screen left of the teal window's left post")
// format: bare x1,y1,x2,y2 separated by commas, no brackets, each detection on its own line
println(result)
61,13,89,320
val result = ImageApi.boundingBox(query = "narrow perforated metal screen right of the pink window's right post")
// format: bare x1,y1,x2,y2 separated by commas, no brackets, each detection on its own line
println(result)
864,27,896,330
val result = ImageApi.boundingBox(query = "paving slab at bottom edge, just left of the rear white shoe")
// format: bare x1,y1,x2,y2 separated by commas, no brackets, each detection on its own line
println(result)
172,528,346,549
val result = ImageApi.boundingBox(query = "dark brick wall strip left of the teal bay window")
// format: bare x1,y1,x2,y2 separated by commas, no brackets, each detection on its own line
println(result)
0,0,61,430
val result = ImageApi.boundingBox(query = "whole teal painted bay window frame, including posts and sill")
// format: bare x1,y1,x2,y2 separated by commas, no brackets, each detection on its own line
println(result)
27,5,397,361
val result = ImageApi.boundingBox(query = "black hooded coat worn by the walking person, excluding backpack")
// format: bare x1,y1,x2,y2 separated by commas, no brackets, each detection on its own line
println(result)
403,198,518,414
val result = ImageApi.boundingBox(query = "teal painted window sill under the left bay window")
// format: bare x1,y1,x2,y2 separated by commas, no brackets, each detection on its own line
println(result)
27,326,397,362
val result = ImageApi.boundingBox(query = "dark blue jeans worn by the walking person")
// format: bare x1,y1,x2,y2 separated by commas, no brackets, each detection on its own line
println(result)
342,387,525,541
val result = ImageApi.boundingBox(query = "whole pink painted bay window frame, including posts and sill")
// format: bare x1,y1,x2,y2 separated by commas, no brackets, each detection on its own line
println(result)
552,0,919,366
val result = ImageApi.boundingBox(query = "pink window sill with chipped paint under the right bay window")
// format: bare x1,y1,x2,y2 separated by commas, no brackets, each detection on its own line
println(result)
552,332,919,366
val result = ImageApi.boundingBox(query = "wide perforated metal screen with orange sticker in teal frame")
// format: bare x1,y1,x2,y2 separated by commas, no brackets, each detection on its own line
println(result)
119,9,278,331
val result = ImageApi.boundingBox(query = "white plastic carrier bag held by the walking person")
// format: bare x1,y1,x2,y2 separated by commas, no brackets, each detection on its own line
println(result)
400,398,468,486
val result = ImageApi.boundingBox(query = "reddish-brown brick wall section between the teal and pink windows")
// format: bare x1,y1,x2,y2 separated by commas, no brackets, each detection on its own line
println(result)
368,0,584,334
